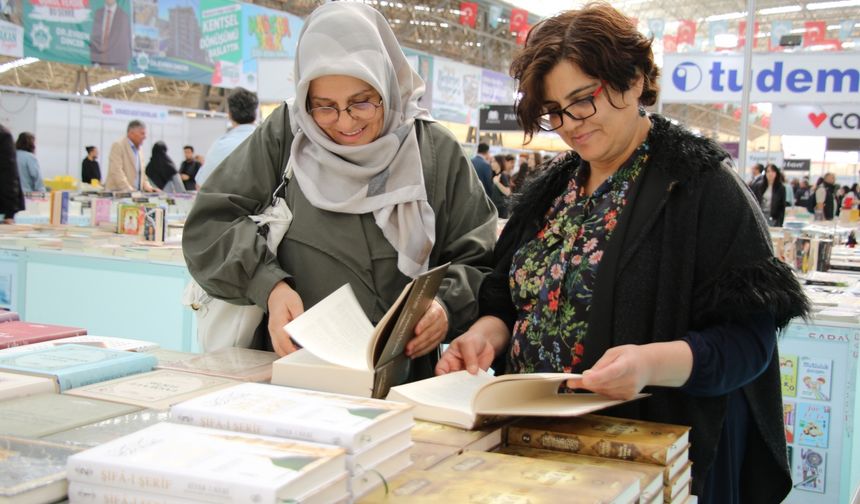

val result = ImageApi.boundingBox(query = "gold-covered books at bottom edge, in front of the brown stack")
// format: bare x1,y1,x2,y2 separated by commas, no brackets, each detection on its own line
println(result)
360,452,639,504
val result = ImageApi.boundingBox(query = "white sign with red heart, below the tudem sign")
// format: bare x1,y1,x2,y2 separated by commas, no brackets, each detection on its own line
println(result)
770,105,860,138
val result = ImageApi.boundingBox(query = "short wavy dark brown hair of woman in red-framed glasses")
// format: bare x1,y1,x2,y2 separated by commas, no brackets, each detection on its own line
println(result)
511,2,660,142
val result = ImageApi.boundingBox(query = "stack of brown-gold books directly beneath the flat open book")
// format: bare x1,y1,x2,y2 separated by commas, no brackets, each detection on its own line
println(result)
505,415,694,504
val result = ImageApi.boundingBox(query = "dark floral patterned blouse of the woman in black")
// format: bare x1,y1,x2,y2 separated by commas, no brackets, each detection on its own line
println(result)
508,141,648,373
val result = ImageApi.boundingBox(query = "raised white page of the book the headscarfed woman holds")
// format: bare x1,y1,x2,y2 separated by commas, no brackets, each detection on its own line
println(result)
284,284,373,371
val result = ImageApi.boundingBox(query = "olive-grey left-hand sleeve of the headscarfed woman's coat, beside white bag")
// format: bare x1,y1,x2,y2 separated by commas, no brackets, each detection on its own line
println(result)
182,105,293,310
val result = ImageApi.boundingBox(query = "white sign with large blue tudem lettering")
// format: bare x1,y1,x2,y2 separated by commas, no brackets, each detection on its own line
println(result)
660,52,860,105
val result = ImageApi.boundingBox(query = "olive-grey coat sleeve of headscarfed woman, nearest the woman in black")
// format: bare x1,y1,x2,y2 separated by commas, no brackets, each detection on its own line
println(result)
421,123,497,338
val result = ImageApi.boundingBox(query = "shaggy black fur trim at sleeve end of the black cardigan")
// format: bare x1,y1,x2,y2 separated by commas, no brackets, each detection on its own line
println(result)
694,257,810,329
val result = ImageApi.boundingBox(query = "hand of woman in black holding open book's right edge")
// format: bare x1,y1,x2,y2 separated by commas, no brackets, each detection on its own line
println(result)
567,345,651,399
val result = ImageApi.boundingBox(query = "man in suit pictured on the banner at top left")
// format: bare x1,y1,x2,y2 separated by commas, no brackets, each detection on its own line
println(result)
90,0,131,70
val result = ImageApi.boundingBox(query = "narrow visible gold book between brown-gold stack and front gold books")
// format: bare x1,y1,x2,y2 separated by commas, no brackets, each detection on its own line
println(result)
499,445,664,502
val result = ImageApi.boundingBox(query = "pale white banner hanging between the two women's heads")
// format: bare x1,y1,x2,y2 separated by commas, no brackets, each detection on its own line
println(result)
432,58,481,126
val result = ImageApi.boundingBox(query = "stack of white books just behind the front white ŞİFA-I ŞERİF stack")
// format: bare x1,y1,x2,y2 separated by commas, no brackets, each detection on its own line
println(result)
170,383,413,499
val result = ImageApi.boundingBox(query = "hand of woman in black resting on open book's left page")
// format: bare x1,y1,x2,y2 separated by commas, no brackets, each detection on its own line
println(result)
436,316,510,375
